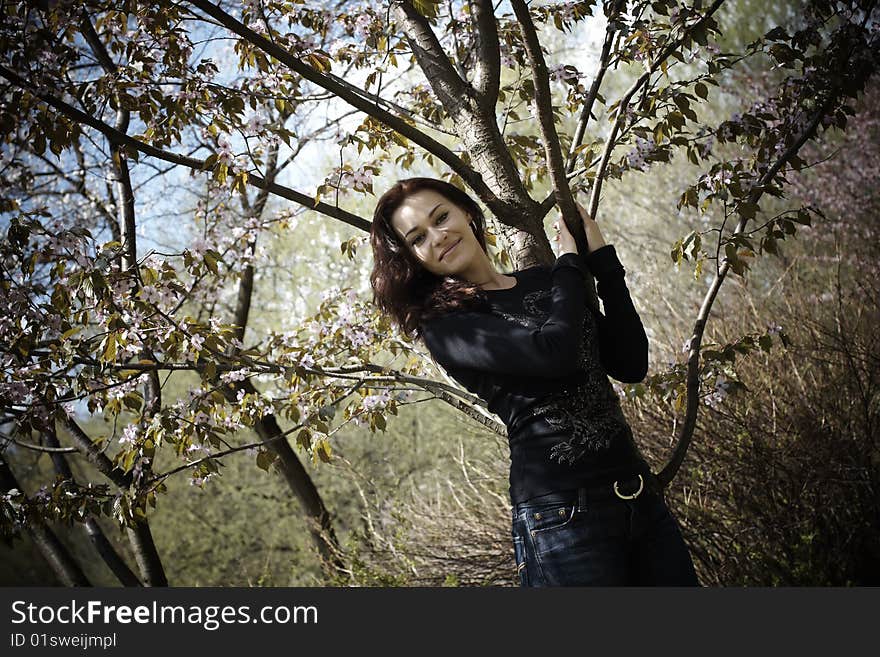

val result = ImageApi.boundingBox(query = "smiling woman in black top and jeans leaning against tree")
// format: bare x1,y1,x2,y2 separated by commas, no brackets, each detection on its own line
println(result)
371,178,697,586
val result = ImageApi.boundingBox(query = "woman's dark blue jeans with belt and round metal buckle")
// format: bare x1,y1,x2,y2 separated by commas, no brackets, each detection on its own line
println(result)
513,478,699,586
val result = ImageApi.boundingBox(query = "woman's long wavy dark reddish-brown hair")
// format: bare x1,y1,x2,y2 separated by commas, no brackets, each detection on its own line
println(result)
370,178,488,336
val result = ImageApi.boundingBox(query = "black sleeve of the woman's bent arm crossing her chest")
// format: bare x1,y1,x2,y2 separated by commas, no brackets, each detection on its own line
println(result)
421,253,587,378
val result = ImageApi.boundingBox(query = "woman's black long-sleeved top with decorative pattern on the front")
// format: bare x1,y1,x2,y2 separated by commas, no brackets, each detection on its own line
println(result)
420,245,648,503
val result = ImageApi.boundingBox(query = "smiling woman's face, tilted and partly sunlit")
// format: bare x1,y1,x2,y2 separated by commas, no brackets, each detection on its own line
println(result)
391,189,482,276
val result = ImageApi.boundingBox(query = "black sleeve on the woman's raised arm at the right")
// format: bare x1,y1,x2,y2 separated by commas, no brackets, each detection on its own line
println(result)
583,244,648,383
